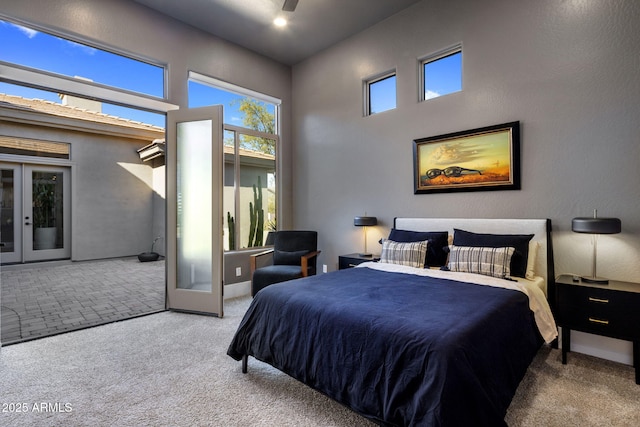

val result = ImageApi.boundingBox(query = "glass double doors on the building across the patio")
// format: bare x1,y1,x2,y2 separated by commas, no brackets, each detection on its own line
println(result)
0,163,71,264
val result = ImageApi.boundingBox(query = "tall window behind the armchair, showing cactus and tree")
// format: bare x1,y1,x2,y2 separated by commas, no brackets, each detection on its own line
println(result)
189,73,280,250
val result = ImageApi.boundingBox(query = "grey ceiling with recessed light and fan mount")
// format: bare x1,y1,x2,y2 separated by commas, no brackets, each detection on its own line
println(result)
134,0,421,65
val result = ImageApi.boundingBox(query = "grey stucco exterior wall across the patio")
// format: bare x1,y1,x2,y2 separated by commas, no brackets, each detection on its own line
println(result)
2,117,159,261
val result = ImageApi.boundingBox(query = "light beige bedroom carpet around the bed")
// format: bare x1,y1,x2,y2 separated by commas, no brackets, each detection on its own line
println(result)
0,298,640,427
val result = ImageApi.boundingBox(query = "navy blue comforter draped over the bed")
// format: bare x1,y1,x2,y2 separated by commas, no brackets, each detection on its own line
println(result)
228,268,542,426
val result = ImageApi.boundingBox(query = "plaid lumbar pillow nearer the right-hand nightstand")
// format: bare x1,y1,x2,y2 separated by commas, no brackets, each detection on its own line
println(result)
449,246,515,279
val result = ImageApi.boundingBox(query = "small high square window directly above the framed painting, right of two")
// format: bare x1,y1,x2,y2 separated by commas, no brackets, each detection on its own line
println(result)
420,46,462,101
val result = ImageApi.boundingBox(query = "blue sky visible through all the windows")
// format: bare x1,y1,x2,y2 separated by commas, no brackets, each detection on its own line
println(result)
0,20,462,127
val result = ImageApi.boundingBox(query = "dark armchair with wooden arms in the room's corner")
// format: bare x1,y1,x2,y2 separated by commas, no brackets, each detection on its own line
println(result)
249,231,320,296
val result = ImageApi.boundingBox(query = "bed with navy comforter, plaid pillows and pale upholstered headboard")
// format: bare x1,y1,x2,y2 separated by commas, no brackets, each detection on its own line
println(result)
227,218,557,426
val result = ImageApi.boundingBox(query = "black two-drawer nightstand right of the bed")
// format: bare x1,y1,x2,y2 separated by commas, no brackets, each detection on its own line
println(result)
555,275,640,384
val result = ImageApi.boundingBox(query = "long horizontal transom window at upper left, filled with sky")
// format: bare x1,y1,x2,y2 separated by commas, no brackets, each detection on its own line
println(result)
0,20,165,98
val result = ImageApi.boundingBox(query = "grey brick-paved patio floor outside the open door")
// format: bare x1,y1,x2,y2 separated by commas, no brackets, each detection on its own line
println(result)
0,257,165,345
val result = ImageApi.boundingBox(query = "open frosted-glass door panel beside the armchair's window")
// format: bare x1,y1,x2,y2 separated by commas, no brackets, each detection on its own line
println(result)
166,106,223,317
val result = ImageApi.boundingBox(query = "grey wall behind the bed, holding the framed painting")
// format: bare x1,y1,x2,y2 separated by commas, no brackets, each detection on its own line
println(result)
293,0,640,361
